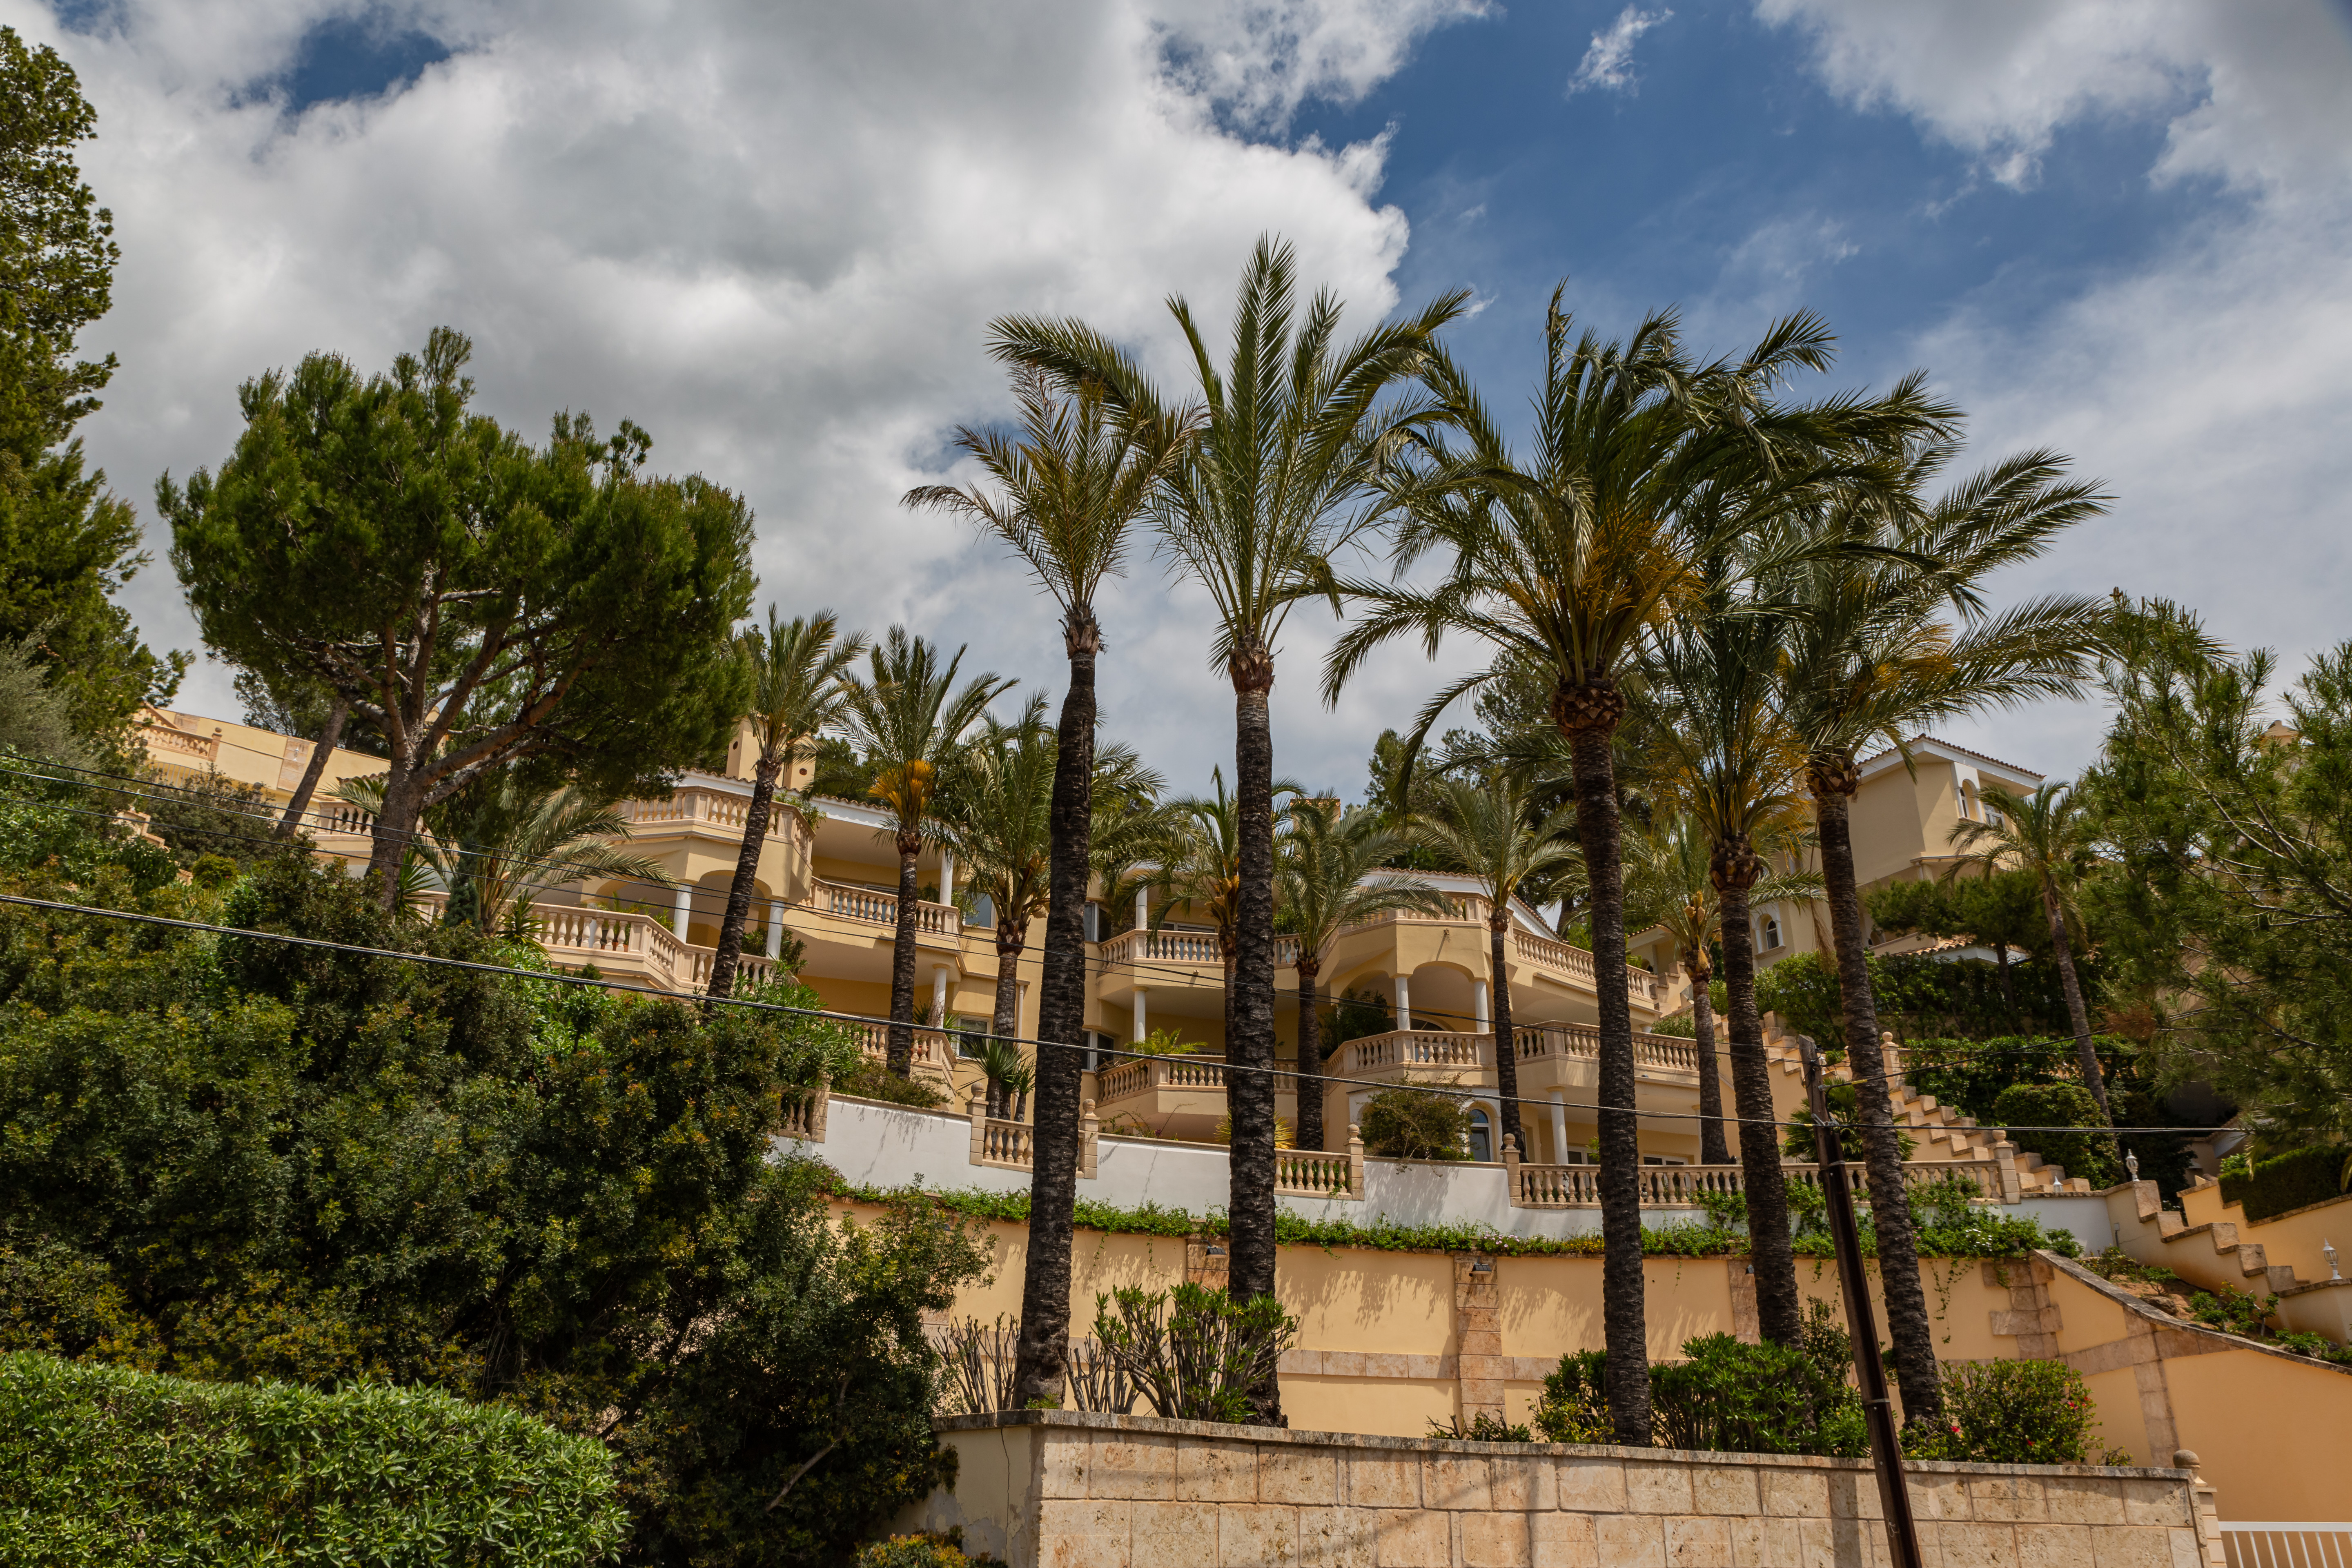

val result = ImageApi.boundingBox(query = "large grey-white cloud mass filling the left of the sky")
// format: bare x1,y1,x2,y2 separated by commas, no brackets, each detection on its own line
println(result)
13,0,1477,788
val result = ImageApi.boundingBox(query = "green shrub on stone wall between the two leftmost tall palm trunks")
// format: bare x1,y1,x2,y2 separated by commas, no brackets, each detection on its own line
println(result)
1094,1283,1298,1422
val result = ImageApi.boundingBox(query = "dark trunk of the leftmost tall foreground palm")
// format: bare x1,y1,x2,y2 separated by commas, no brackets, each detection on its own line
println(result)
1014,604,1103,1408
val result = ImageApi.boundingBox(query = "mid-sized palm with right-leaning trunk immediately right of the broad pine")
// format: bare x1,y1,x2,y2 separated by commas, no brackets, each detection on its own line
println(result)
710,604,866,997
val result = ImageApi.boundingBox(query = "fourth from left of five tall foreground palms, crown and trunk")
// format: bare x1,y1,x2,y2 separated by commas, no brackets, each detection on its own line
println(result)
1635,564,1818,1345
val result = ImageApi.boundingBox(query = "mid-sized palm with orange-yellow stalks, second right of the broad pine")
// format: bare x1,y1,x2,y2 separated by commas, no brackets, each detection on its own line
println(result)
842,625,1011,1077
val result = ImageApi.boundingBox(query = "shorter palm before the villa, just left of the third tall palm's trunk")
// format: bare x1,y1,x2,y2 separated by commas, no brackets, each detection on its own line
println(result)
1414,769,1583,1154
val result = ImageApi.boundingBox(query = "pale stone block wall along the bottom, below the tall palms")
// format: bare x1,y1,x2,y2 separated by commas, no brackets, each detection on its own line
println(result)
898,1410,2223,1568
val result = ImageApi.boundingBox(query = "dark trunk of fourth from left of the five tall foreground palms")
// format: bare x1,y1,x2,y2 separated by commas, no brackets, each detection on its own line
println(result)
1712,865,1804,1345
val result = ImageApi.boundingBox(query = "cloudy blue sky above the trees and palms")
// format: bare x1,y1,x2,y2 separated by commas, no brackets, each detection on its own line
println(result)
18,0,2352,795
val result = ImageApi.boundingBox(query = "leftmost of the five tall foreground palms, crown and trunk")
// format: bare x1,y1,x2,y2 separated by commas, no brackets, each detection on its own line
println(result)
906,364,1188,1406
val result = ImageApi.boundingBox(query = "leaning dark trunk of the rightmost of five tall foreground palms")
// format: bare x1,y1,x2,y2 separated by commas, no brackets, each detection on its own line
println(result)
1806,757,1943,1425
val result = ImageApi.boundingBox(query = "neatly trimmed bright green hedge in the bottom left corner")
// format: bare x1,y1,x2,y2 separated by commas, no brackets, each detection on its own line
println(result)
0,1354,628,1568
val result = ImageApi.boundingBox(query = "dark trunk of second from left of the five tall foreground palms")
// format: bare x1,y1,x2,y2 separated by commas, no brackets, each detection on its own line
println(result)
1225,644,1282,1427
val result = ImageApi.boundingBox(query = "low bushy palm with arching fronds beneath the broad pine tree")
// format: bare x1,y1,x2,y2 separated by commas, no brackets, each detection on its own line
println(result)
336,769,670,938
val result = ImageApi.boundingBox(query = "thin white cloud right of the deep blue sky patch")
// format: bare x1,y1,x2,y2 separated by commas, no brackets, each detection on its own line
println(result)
1757,0,2352,771
